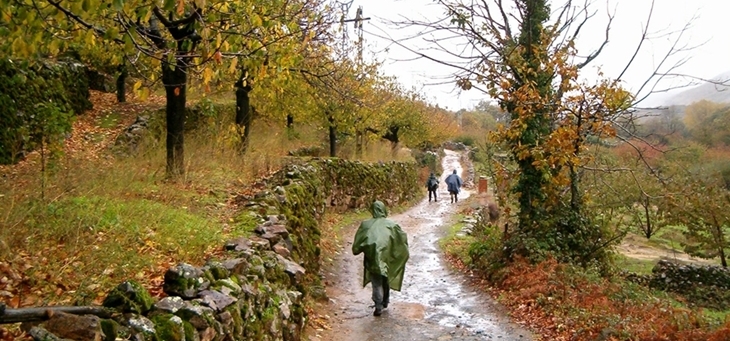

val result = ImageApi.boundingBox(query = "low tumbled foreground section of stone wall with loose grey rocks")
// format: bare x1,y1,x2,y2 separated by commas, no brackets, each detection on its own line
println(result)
30,216,305,341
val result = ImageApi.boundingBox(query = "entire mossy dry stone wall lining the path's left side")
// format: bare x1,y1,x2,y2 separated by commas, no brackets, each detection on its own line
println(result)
23,159,420,341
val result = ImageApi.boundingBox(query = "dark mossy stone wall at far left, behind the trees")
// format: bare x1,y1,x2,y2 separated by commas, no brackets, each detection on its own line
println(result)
0,58,91,164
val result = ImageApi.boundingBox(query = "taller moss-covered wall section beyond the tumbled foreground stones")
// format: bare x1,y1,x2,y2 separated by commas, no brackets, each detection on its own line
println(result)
249,158,421,285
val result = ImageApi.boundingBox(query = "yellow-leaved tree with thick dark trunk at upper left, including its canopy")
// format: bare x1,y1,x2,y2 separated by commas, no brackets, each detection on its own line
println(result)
0,0,336,177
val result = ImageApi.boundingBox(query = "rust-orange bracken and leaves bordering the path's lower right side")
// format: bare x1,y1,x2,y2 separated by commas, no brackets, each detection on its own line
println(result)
440,251,730,341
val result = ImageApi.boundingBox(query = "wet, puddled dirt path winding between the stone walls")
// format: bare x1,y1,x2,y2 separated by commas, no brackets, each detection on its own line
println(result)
308,151,531,341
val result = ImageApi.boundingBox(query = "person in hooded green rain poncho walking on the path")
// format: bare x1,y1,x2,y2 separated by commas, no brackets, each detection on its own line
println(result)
352,200,409,316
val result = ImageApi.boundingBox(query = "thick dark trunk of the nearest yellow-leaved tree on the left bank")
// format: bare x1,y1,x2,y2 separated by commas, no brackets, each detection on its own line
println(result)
162,60,188,177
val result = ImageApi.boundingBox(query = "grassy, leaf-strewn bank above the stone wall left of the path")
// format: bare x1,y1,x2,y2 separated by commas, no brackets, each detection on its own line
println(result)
0,93,418,314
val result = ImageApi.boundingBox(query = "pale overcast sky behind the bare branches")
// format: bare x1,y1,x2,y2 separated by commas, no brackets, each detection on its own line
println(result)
348,0,730,110
